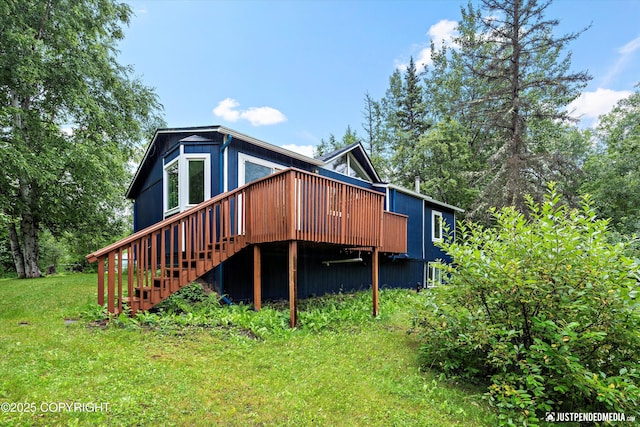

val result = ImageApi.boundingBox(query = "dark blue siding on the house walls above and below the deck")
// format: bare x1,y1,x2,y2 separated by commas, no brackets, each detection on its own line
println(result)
132,130,455,301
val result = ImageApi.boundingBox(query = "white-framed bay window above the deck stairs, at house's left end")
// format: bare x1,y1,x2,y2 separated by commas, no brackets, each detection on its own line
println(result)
164,148,211,218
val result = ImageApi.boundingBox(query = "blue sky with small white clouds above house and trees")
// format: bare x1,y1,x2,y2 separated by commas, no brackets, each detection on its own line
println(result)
119,0,640,155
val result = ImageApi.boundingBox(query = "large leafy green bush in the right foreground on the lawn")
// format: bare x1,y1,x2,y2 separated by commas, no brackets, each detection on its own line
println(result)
414,186,640,425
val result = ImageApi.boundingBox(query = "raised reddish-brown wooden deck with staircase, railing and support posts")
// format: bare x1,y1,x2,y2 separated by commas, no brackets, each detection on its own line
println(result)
87,169,407,324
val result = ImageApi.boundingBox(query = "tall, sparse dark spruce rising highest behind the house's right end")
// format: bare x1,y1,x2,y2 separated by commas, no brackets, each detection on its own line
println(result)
436,0,590,217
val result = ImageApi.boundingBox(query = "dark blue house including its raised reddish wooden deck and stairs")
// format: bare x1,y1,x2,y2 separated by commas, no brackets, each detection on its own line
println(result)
87,126,461,323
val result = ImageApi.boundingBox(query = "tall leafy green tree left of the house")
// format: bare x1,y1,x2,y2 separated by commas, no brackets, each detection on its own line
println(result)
0,0,160,278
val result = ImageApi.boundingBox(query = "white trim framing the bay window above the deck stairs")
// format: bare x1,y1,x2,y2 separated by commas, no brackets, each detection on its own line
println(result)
162,150,211,218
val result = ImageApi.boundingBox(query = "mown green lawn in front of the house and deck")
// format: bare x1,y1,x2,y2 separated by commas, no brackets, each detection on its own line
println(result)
0,274,495,426
